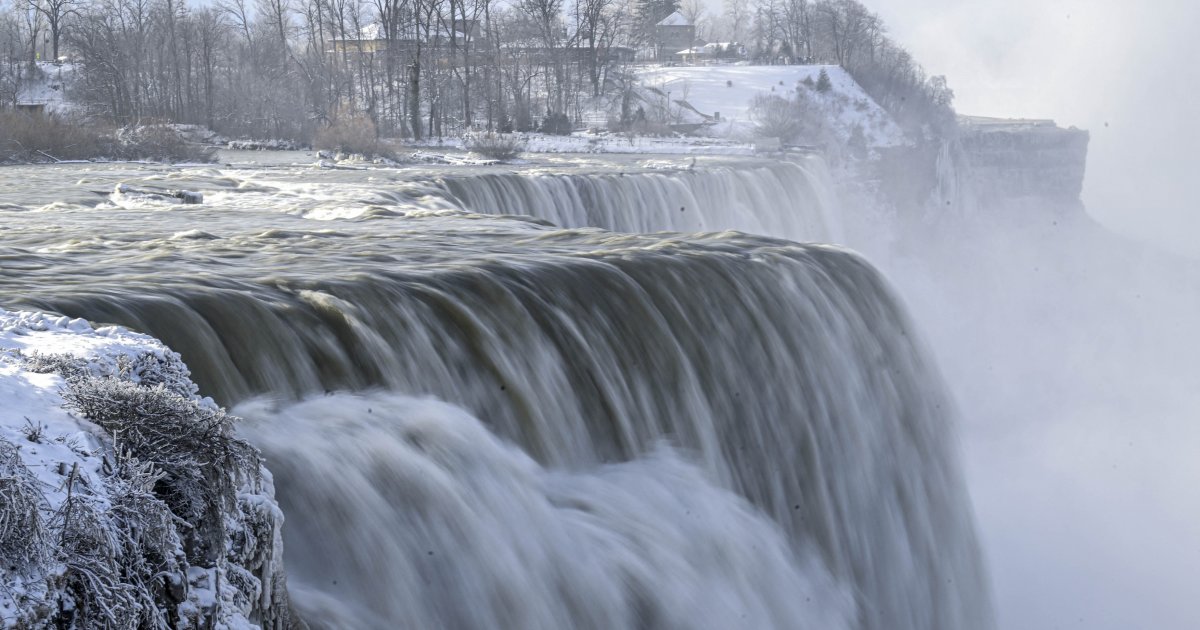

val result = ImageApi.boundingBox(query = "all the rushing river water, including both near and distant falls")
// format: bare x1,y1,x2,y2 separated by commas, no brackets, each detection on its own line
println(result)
0,153,990,630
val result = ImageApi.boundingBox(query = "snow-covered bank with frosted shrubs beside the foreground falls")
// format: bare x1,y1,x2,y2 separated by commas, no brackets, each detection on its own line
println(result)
0,310,292,630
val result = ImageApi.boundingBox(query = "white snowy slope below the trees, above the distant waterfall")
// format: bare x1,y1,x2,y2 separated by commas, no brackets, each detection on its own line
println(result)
638,65,905,148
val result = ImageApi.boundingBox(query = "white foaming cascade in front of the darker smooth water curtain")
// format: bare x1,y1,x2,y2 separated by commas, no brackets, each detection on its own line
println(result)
239,394,852,630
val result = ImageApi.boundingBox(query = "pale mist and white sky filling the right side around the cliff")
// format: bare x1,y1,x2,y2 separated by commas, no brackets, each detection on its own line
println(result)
870,0,1200,630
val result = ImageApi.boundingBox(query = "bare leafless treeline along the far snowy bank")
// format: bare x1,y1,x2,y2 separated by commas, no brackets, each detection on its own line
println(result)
0,0,952,139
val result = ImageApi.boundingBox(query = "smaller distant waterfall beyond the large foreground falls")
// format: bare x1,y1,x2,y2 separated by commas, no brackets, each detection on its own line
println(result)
444,157,842,242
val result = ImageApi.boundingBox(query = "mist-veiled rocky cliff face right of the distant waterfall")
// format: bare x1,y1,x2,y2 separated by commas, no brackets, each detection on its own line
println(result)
835,118,1090,253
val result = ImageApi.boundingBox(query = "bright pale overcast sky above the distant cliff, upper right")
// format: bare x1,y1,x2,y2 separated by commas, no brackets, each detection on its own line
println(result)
865,0,1200,258
